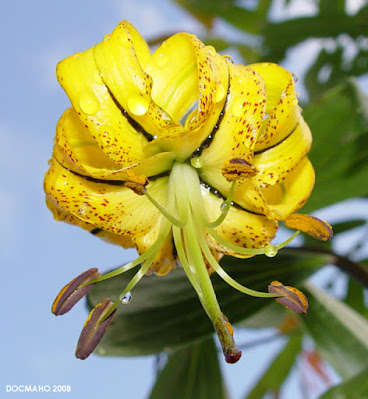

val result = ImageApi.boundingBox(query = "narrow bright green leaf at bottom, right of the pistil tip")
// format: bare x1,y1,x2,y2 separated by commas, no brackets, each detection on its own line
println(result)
245,334,303,399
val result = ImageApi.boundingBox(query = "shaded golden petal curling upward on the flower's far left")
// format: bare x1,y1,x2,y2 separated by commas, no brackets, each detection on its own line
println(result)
54,108,175,180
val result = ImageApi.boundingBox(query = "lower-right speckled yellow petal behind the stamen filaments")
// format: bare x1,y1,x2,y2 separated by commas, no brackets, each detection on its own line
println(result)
201,188,277,257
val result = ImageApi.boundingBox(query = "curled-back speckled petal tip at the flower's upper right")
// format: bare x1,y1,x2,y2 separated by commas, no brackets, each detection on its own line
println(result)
249,63,300,151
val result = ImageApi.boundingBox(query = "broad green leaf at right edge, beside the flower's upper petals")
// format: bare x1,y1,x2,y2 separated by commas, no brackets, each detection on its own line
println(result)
303,79,368,213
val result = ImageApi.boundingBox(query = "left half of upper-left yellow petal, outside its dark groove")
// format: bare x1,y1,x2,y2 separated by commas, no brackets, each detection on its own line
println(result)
57,48,148,166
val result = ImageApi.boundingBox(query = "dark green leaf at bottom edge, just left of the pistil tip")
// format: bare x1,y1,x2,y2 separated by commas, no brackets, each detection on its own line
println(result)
149,338,227,399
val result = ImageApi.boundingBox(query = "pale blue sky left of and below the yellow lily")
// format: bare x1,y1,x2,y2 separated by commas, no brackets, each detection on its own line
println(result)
0,0,366,399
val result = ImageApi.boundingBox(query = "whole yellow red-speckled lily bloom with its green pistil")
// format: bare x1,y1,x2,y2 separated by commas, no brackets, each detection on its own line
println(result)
44,21,332,362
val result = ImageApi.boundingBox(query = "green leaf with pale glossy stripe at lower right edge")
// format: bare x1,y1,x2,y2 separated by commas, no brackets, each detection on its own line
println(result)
301,283,368,378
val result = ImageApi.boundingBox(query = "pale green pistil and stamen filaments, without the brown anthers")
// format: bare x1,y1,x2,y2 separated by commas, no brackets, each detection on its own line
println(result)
88,162,299,363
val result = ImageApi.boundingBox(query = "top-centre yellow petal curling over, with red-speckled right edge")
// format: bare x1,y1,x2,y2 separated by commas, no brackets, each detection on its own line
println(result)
145,33,228,160
